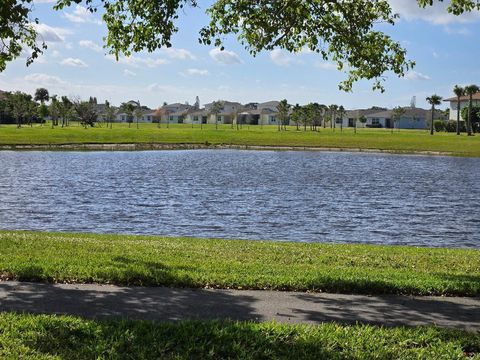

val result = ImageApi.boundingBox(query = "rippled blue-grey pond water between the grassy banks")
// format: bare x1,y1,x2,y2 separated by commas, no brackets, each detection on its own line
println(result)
0,150,480,248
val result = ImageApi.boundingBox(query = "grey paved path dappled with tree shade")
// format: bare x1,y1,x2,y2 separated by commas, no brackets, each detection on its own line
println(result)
0,282,480,331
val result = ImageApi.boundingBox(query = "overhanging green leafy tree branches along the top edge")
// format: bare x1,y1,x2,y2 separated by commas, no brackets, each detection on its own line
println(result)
0,0,480,91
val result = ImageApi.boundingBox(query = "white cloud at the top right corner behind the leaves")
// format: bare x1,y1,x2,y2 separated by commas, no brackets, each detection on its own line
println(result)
389,0,480,25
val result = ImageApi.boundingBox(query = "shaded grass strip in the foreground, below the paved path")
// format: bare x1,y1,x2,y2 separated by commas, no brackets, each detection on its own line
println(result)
0,313,480,359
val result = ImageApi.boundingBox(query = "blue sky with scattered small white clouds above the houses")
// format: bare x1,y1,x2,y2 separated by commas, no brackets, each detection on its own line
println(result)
0,0,480,109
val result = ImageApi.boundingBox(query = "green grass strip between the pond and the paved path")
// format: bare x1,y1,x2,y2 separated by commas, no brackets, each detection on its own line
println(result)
0,231,480,296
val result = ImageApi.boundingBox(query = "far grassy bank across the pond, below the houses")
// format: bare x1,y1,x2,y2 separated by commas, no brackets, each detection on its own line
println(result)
0,124,480,157
